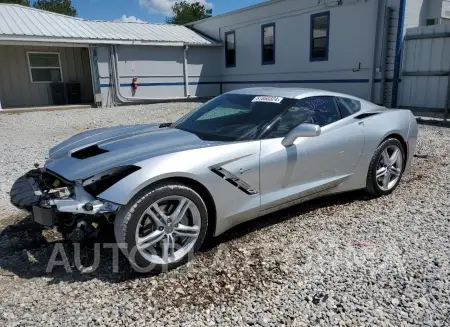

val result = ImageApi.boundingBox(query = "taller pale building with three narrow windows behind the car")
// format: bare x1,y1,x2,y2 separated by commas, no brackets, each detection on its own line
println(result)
189,0,445,105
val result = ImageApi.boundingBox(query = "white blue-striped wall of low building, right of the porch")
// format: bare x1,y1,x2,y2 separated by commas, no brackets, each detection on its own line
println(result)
98,46,222,106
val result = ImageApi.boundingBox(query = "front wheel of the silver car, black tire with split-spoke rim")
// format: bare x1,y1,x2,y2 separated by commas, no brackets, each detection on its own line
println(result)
114,181,208,273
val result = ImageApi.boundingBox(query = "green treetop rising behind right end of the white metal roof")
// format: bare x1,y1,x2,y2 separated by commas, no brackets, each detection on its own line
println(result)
166,0,212,25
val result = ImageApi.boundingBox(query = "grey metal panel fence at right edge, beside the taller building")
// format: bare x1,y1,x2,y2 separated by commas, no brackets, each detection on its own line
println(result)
399,24,450,120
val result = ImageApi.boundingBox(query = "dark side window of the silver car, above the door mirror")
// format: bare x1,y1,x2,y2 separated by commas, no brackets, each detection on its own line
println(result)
266,96,341,138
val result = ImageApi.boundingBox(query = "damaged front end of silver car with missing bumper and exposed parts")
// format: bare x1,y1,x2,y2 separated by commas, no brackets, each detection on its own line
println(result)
10,166,130,242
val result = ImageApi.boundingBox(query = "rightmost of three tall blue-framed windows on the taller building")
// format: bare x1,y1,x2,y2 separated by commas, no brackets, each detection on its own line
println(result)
310,11,330,61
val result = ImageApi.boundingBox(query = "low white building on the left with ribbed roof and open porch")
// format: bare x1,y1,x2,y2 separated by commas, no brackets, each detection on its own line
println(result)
0,4,221,108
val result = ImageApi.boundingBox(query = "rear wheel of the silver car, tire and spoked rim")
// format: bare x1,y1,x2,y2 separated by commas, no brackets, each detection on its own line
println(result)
365,138,406,197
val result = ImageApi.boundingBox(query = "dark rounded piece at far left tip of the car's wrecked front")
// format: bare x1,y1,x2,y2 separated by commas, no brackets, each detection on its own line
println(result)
9,174,40,212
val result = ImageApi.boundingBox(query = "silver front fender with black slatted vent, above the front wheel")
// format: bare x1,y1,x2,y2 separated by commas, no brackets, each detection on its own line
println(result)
98,141,261,235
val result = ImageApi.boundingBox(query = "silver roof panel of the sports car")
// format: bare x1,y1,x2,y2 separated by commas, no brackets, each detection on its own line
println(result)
227,87,378,107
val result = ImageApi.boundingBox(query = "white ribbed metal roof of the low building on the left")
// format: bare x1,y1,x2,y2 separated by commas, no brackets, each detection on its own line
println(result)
0,4,217,45
